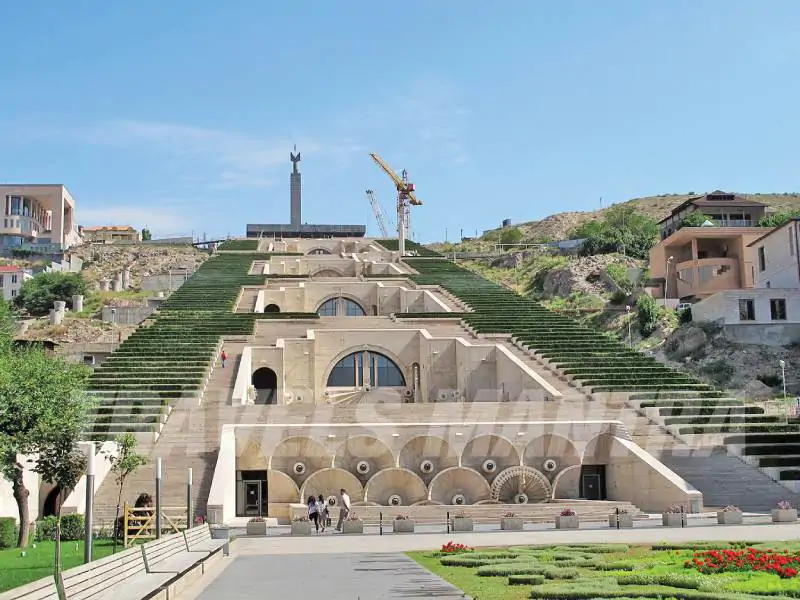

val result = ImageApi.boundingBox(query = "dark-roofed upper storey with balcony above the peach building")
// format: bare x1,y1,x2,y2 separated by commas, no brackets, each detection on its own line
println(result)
658,190,767,240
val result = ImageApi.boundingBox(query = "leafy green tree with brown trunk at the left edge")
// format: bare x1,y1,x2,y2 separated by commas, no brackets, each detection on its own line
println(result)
0,346,90,548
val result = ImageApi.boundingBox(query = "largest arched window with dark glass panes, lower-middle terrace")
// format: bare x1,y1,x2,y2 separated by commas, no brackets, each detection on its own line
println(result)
324,348,406,388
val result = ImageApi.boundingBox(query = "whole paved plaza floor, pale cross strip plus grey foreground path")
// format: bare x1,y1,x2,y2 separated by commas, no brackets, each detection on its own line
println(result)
180,520,800,600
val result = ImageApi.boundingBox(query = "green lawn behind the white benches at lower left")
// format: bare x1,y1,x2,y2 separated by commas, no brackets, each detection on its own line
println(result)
0,540,116,592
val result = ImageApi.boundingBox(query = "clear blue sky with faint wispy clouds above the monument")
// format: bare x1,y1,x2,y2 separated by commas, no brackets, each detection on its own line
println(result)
0,0,800,241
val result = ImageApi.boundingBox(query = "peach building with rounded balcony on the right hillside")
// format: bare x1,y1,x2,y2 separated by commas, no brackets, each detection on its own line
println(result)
650,227,764,301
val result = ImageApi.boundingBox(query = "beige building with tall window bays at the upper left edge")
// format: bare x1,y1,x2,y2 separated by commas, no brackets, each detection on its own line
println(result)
0,184,81,253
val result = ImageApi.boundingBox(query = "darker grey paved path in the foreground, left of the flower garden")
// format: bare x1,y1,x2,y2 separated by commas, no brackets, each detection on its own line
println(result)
191,553,465,600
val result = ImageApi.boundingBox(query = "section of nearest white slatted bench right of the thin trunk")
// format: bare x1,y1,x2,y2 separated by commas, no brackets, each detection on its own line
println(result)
61,546,175,600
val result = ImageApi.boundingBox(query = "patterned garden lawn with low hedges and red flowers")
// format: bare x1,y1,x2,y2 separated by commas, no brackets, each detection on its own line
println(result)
409,542,800,600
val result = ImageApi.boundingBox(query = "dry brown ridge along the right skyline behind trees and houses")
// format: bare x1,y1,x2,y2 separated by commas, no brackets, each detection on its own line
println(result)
431,192,800,250
